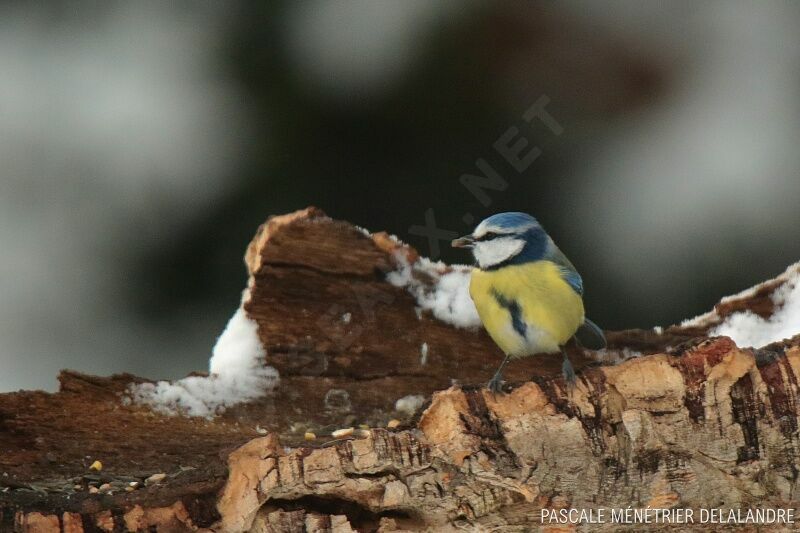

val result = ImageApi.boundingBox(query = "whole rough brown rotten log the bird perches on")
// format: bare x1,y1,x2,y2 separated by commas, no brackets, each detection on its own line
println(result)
0,208,800,531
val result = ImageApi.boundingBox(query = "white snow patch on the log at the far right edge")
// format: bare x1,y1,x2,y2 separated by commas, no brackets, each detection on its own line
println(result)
709,263,800,348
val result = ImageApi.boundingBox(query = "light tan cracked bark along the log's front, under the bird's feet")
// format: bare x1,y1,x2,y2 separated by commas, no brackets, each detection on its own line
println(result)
219,338,800,531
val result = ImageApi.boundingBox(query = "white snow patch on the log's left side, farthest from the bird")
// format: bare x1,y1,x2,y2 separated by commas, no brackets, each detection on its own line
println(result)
128,300,279,418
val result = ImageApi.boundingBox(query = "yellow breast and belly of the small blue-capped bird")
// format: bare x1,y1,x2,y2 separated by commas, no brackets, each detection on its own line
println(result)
469,261,584,357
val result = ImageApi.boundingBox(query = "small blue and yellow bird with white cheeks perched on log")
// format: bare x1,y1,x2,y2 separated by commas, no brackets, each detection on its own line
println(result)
451,212,606,393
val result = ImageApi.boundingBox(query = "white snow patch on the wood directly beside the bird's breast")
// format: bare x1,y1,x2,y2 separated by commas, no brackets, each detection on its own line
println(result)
386,254,481,328
